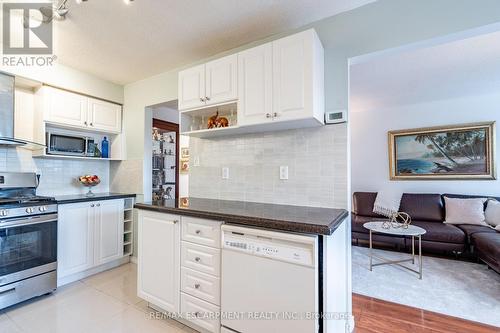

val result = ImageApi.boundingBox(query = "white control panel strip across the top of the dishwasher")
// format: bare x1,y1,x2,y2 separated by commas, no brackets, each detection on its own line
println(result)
223,233,315,266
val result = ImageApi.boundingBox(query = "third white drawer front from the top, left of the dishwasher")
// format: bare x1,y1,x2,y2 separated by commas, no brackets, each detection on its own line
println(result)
181,267,220,305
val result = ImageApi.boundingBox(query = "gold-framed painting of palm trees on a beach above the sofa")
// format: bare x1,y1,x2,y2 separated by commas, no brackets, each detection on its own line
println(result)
389,122,496,180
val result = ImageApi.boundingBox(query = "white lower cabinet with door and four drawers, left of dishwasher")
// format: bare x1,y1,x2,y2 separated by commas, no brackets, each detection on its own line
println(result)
137,210,222,333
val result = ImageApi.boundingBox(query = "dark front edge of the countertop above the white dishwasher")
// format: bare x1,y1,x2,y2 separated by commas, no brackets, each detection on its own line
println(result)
134,203,349,236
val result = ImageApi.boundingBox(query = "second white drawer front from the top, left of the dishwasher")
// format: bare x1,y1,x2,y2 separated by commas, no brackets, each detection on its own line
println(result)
181,241,220,276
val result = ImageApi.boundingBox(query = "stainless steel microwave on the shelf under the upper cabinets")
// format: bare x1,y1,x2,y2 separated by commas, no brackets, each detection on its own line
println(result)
47,132,94,156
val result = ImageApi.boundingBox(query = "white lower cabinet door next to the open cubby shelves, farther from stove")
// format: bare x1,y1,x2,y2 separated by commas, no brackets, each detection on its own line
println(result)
94,200,124,265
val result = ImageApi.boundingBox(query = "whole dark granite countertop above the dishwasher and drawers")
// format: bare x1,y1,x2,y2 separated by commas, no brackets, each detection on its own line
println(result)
134,198,349,235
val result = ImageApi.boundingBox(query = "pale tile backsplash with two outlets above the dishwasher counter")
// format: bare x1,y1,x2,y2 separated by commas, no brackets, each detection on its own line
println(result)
189,124,347,208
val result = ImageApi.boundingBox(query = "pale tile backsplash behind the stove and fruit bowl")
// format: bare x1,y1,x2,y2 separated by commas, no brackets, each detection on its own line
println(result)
0,147,109,196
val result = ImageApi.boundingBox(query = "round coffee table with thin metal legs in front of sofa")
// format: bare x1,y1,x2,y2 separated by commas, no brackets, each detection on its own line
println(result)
363,221,426,279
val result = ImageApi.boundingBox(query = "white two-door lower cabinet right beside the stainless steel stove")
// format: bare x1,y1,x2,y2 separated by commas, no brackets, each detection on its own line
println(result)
57,199,124,282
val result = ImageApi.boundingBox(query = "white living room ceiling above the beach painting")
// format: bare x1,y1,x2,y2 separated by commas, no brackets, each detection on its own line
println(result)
350,32,500,112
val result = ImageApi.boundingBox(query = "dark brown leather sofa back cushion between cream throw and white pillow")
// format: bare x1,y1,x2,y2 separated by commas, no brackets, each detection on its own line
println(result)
399,193,444,222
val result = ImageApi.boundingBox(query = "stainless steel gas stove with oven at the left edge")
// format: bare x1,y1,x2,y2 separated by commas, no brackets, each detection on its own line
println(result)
0,173,57,309
